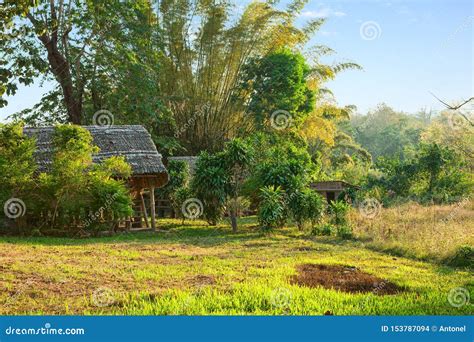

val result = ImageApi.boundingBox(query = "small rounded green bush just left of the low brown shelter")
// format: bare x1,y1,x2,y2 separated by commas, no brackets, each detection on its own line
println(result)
288,188,324,229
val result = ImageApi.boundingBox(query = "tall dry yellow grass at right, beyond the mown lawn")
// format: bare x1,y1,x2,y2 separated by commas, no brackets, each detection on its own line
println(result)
351,200,474,261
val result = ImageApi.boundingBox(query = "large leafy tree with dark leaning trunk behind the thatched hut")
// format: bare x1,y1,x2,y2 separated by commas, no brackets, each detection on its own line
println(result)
0,0,165,124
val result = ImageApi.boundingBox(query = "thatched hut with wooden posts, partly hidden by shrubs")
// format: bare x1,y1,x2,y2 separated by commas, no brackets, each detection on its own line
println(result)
24,125,168,229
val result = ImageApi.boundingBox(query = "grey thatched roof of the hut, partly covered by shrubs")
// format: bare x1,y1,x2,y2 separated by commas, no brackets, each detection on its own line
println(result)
24,125,168,178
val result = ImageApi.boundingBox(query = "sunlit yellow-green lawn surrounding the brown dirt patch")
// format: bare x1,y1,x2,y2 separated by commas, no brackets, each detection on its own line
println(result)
0,214,474,315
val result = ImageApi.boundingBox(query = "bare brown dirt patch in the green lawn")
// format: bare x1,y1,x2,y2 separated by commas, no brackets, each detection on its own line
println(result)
290,264,405,295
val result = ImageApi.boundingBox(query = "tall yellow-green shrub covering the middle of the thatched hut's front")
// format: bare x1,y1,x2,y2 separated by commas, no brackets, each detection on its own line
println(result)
38,125,132,233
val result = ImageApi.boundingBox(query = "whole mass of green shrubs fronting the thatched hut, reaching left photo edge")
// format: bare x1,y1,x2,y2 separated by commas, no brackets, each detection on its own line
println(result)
0,124,132,234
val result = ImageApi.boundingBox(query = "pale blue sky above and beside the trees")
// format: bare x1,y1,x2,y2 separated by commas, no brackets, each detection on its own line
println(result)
0,0,474,120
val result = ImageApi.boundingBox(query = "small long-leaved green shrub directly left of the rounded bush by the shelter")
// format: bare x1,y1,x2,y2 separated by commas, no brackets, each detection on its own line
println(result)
258,186,285,230
